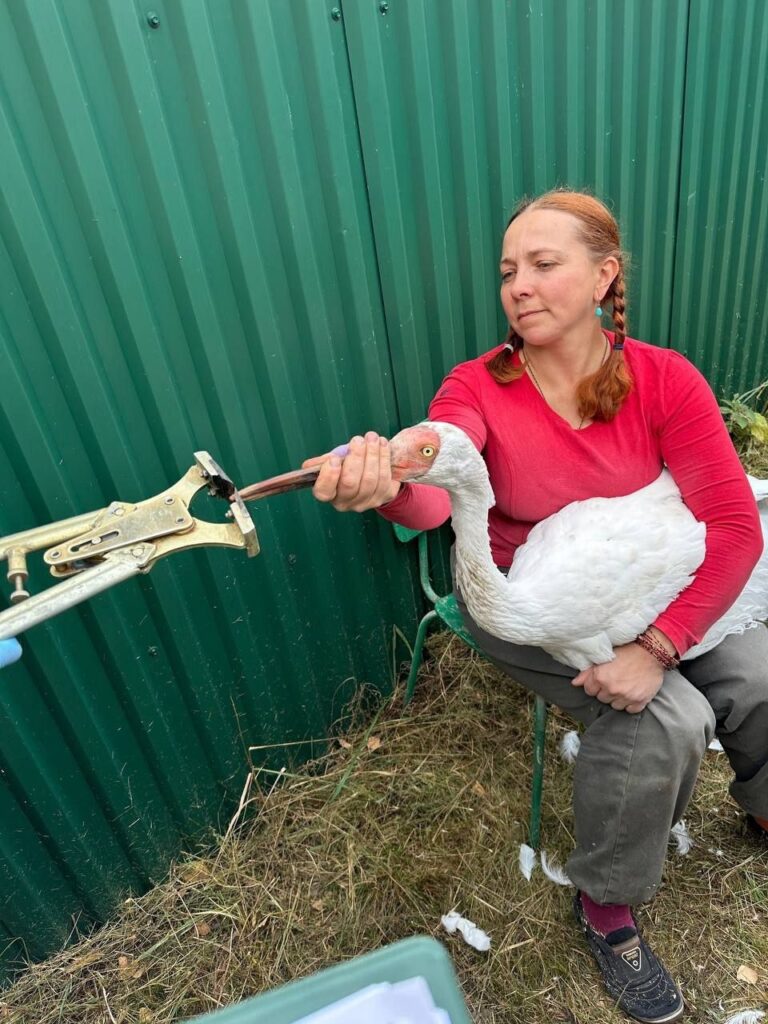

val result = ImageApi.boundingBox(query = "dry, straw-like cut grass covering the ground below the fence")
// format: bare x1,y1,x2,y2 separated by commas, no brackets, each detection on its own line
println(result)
0,636,768,1024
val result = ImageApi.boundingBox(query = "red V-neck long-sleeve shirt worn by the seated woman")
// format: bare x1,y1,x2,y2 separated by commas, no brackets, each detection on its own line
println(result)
379,334,763,654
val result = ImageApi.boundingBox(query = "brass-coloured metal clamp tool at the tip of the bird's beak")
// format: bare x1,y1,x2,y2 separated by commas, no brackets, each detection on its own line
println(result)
0,452,259,640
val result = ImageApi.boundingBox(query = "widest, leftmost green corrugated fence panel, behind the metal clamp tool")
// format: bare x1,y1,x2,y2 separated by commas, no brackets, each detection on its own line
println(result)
0,0,415,974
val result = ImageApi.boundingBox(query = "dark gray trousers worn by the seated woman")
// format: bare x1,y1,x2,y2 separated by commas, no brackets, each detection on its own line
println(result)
455,591,768,903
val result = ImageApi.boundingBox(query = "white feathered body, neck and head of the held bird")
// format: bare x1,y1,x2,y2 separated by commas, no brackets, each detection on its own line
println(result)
391,421,768,669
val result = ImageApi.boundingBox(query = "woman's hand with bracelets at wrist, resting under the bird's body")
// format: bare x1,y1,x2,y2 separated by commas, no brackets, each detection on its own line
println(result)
571,643,664,715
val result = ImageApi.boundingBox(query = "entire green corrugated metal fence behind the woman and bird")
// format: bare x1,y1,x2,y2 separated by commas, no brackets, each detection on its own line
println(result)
0,0,768,974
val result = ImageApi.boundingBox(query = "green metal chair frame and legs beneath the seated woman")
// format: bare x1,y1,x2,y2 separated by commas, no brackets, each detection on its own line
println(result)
393,523,547,850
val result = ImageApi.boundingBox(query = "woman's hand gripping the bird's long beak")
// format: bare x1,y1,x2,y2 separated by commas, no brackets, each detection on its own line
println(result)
302,430,400,512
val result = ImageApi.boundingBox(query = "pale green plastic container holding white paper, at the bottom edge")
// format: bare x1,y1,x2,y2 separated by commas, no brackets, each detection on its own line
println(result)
186,936,472,1024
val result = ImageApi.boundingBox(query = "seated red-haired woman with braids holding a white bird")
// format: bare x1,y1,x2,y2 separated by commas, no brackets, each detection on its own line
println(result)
307,190,768,1022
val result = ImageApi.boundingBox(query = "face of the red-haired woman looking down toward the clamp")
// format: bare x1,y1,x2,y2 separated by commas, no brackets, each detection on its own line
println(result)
501,210,618,345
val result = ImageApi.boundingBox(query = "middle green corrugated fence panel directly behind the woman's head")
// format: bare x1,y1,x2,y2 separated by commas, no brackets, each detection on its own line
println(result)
343,0,687,420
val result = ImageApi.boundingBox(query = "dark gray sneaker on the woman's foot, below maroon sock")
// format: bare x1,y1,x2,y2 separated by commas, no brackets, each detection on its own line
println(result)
573,892,685,1024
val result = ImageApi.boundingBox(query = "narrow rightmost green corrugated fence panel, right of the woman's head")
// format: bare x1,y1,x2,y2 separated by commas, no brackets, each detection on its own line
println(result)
672,0,768,393
